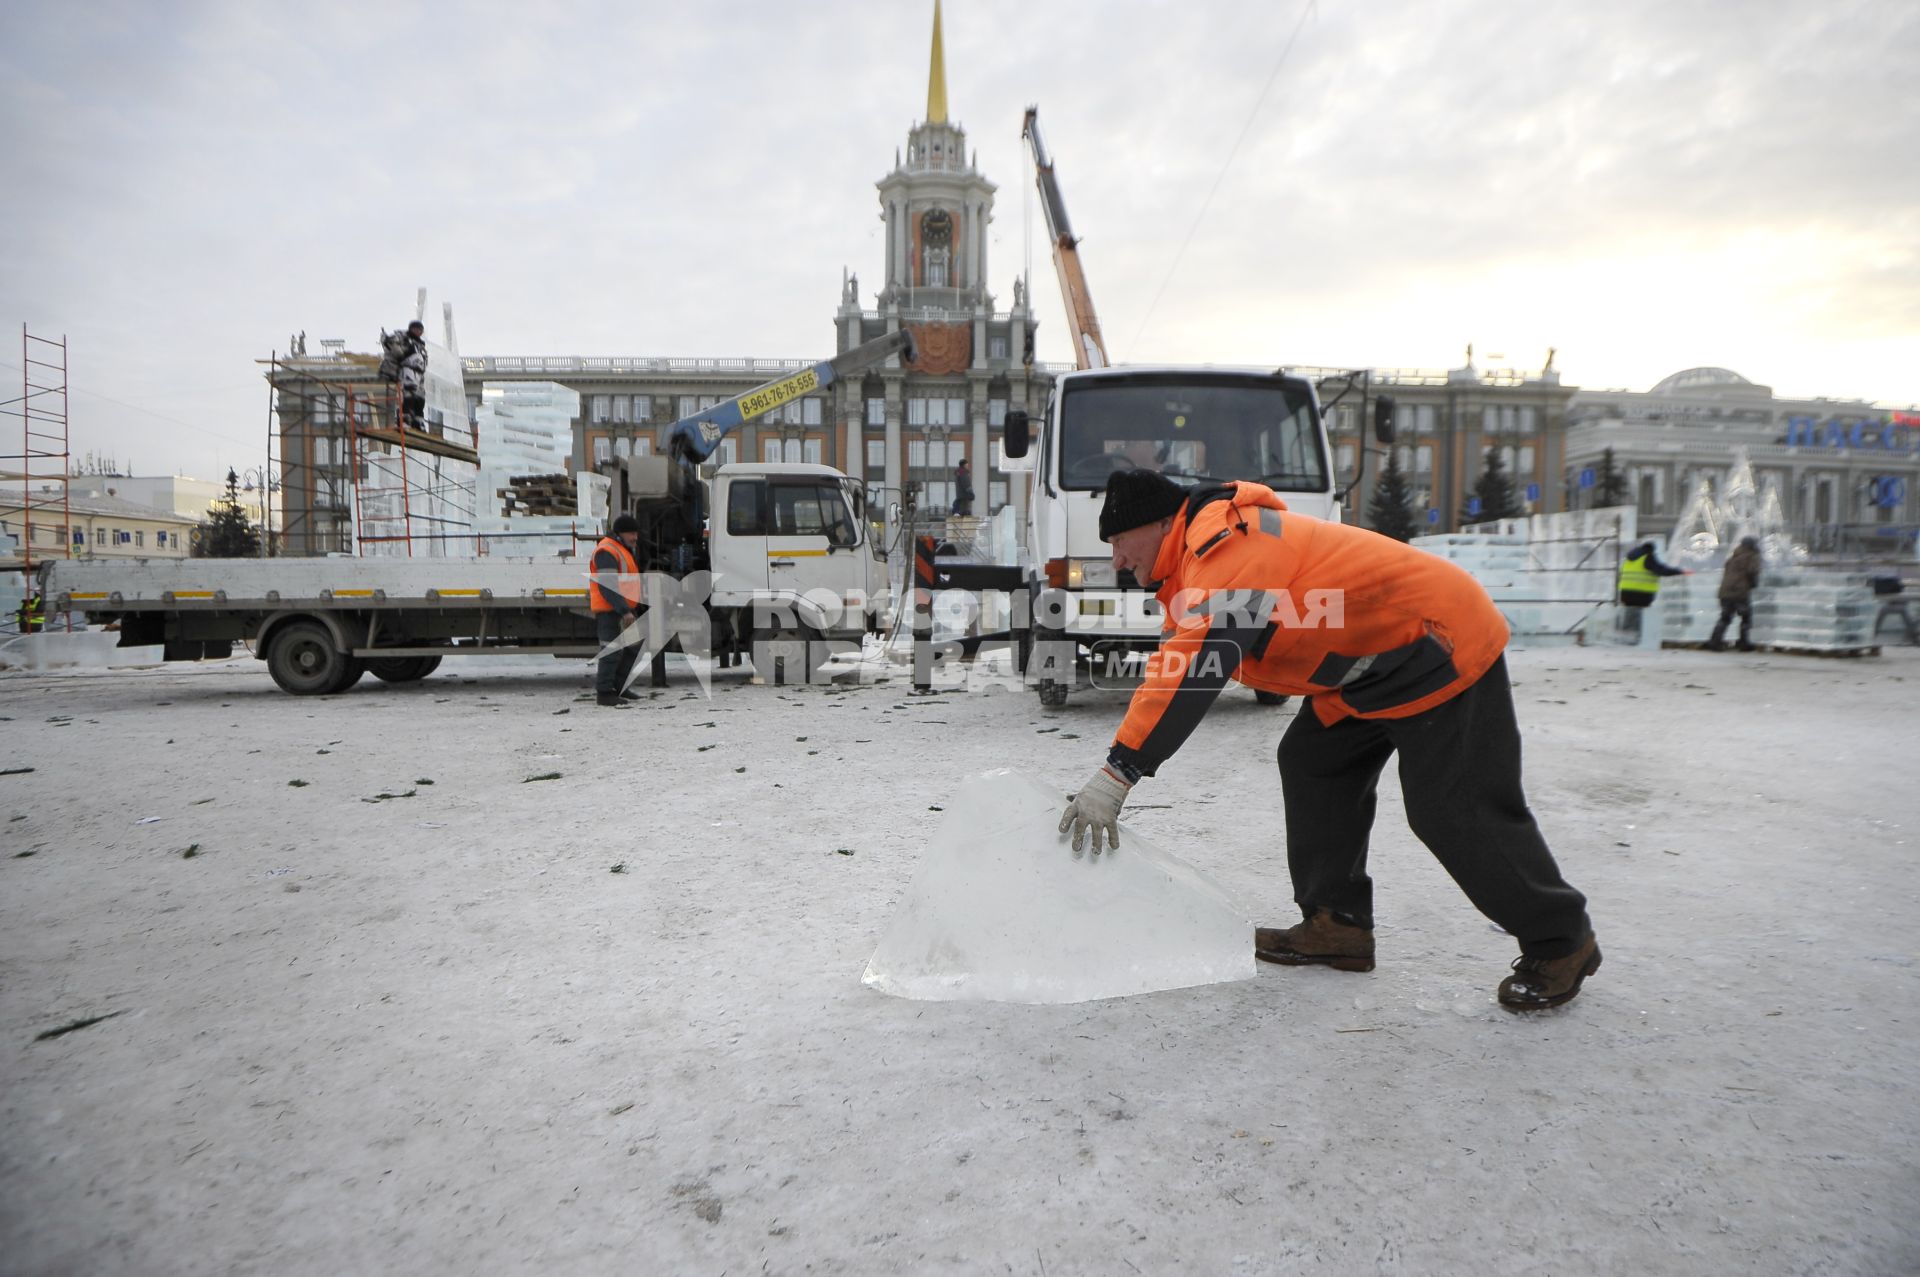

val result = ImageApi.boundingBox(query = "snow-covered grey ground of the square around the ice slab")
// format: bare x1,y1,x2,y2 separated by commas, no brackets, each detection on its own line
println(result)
0,649,1920,1275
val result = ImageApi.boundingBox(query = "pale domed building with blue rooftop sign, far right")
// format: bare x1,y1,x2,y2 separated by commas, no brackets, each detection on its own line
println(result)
1561,369,1920,553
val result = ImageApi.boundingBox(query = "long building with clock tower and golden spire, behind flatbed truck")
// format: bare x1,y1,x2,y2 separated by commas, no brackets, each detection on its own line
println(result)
269,12,1064,555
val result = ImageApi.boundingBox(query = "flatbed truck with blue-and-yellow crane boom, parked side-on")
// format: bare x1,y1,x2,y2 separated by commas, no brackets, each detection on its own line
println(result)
40,330,914,695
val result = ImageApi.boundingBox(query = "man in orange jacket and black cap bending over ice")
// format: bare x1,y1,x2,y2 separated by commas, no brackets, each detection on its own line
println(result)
1060,470,1599,1010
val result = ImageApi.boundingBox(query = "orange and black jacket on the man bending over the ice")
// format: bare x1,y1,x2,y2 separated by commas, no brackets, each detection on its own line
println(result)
1108,482,1507,780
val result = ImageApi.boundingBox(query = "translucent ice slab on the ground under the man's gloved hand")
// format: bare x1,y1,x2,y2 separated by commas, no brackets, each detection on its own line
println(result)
862,770,1254,1004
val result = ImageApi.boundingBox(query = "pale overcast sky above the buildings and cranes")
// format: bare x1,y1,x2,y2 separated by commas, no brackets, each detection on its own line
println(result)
0,0,1920,478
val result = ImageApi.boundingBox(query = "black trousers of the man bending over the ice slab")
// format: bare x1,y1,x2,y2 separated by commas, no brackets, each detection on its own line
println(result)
1281,657,1588,958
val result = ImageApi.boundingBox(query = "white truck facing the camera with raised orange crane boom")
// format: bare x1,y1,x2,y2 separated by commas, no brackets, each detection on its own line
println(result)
916,108,1392,709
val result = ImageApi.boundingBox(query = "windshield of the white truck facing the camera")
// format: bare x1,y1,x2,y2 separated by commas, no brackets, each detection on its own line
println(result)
1060,373,1329,492
